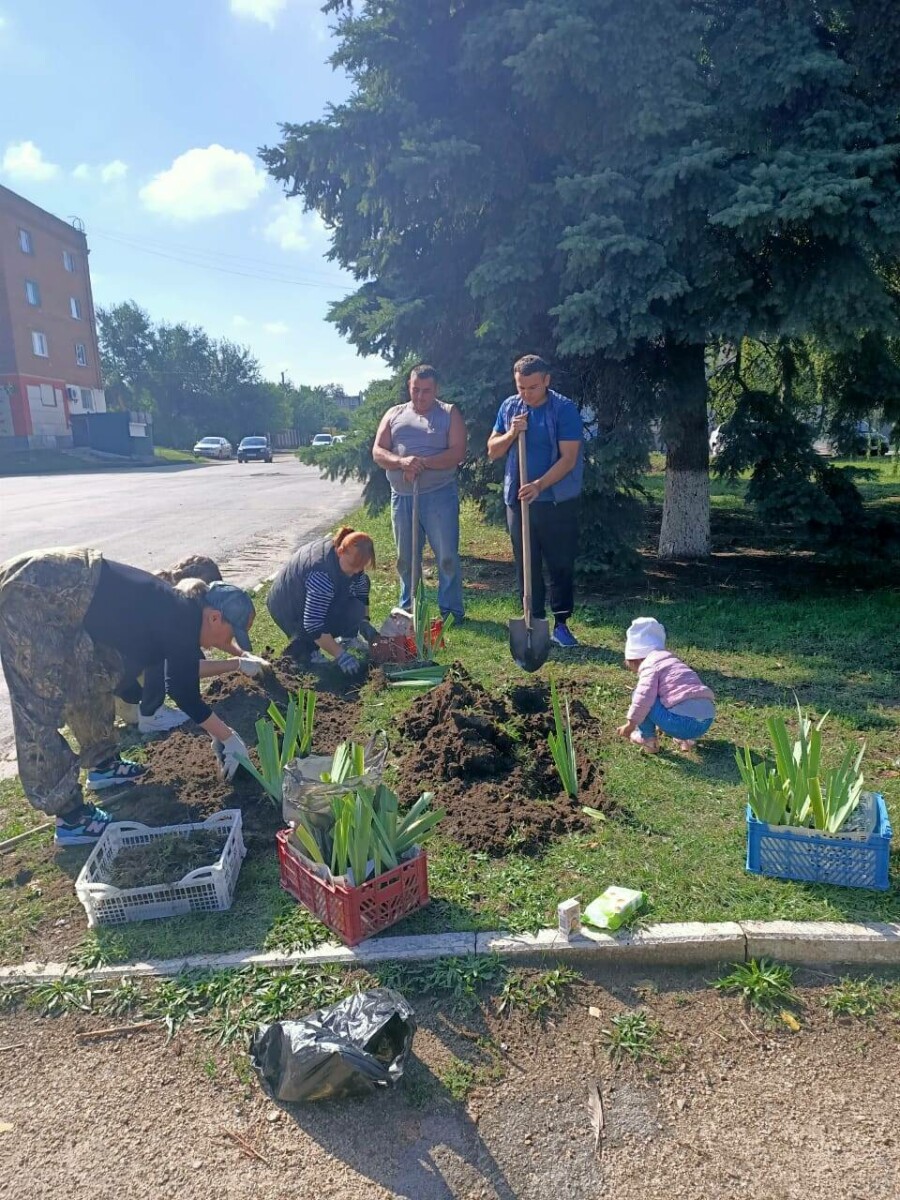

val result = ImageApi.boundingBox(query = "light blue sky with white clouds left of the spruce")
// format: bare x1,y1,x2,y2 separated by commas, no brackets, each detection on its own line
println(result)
0,0,384,391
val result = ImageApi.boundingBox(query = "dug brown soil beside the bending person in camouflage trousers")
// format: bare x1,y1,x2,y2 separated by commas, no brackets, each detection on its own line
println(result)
116,658,360,844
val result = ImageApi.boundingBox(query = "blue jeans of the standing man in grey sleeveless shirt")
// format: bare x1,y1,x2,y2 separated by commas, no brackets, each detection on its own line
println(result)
391,480,463,620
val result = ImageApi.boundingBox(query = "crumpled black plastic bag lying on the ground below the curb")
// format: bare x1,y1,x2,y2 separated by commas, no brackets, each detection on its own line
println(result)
250,988,415,1103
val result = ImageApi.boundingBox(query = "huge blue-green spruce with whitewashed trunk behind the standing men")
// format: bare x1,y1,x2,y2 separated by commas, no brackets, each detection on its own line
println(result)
263,0,900,557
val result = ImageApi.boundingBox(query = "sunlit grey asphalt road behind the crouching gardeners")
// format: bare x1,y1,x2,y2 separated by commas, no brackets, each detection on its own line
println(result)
0,456,361,778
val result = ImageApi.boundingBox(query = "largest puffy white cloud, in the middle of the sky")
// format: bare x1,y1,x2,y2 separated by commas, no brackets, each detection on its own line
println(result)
140,143,265,221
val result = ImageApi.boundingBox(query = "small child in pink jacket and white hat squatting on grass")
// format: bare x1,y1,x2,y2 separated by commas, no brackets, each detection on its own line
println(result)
616,617,715,754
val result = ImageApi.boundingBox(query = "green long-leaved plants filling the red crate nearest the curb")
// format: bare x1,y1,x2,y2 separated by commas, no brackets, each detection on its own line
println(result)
294,743,445,883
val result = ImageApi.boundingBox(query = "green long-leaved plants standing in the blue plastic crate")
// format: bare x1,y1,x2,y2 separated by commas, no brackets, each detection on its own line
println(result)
734,702,865,833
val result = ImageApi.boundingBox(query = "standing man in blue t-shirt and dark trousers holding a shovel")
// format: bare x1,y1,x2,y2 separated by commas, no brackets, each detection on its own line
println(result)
487,354,584,649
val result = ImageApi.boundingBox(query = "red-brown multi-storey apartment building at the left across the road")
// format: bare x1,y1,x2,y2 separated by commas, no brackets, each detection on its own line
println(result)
0,186,107,448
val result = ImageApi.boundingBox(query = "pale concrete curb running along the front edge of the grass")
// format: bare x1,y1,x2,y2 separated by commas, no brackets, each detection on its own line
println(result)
0,920,900,986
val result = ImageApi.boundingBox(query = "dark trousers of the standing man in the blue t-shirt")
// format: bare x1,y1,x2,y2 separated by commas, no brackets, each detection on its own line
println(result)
506,497,578,622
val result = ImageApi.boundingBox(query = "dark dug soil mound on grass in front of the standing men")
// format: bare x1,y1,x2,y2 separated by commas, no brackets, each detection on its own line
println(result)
397,666,610,856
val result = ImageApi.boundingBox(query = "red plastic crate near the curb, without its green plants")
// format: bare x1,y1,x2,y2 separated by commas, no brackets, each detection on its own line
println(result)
275,829,428,946
